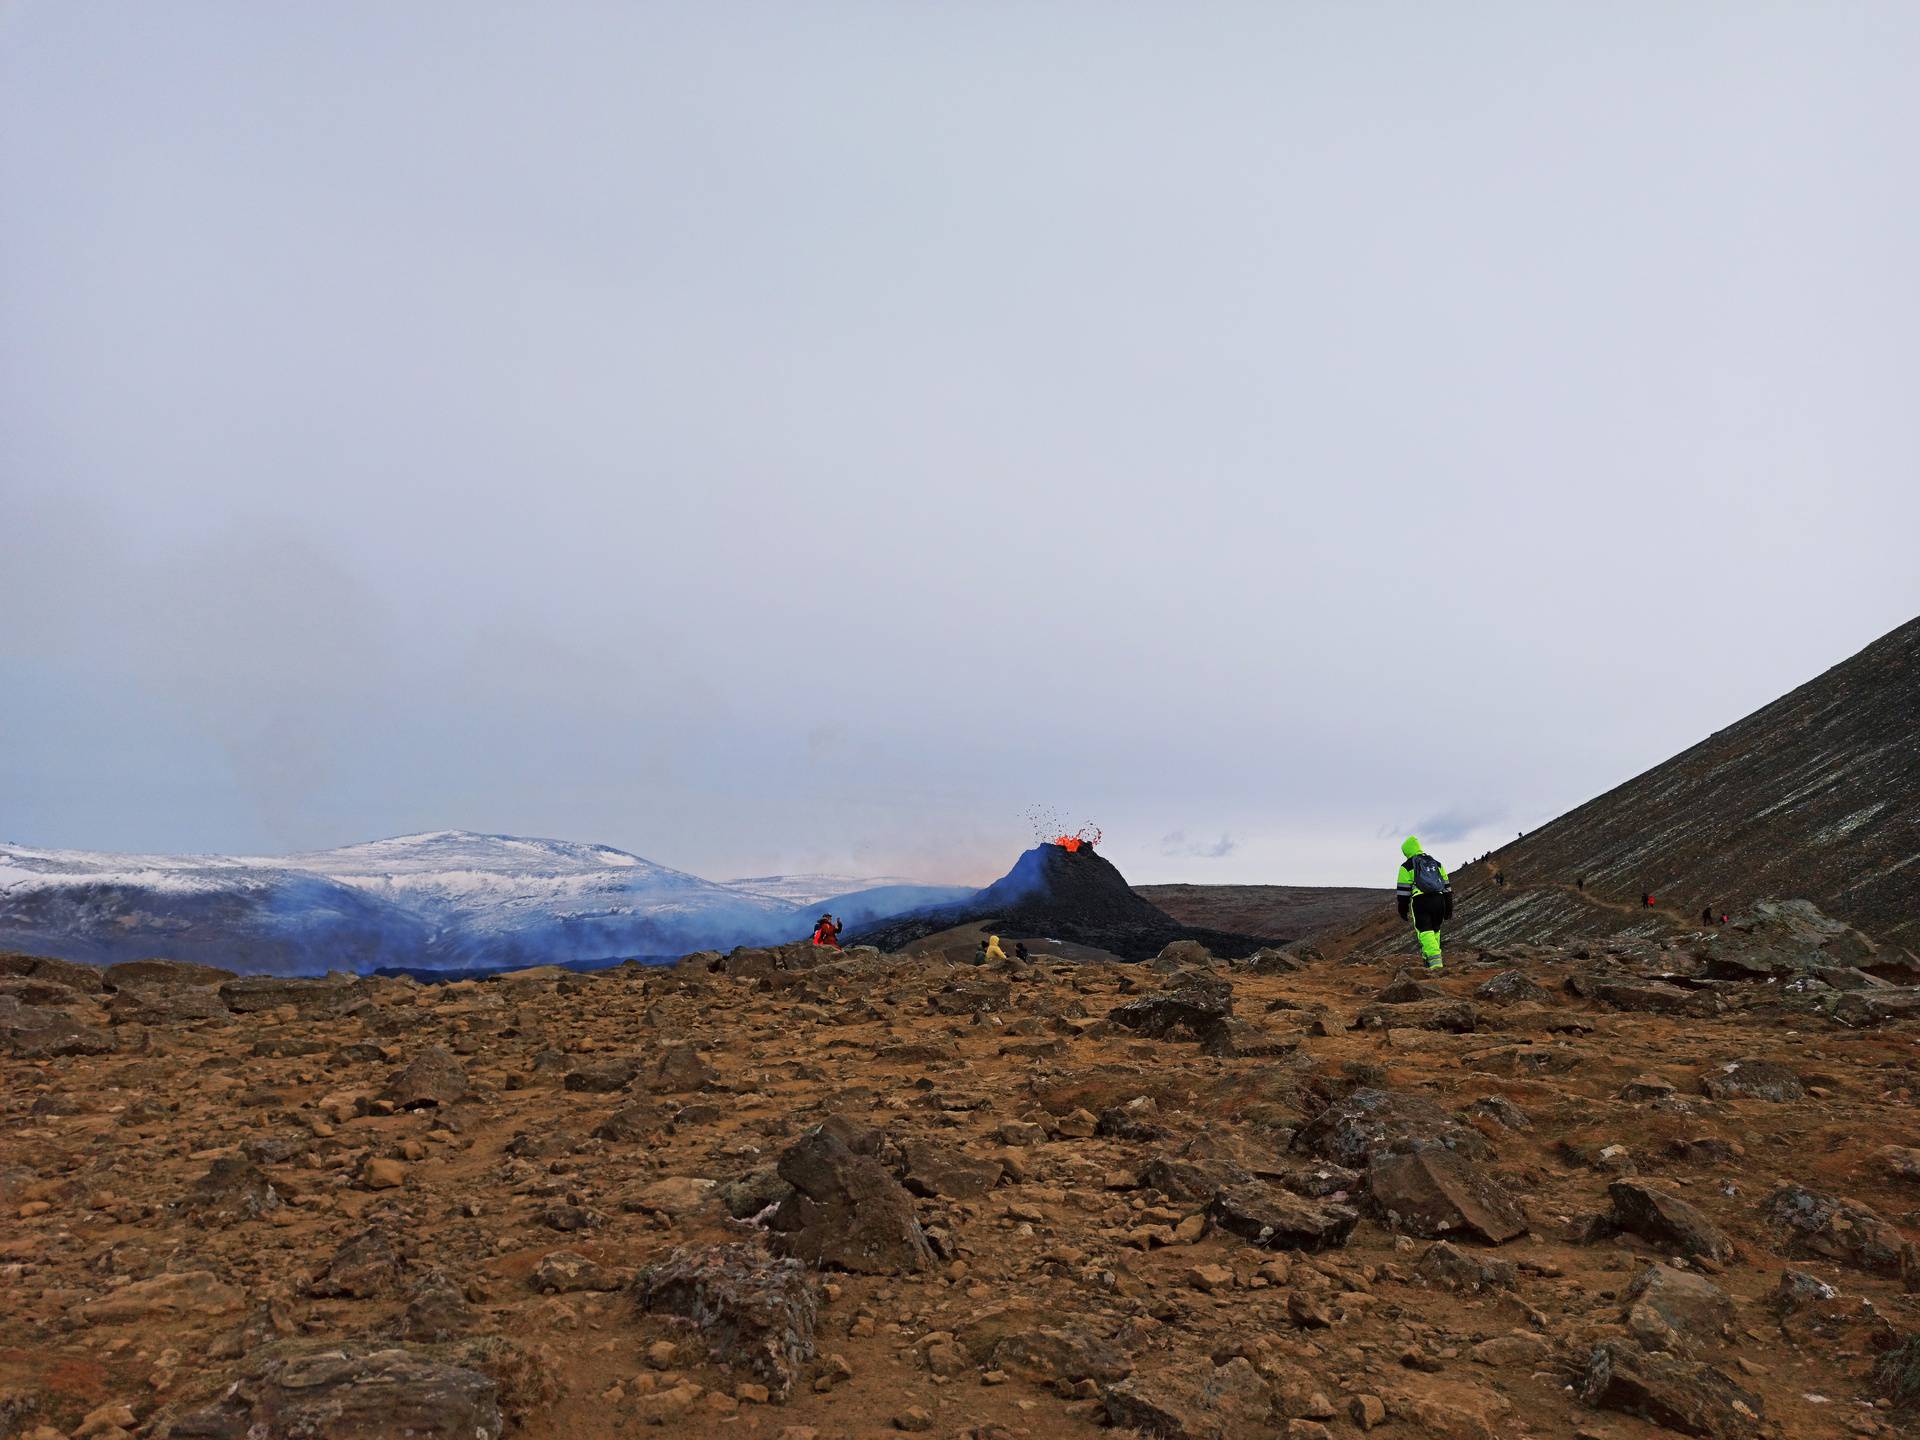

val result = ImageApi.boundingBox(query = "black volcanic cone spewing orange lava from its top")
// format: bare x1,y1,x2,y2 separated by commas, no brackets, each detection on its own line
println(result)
852,826,1292,960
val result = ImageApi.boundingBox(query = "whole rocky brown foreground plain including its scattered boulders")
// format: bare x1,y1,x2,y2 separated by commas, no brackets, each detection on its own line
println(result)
0,925,1920,1440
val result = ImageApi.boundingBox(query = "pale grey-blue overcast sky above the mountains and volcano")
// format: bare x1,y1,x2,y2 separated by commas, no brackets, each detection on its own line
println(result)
0,0,1920,885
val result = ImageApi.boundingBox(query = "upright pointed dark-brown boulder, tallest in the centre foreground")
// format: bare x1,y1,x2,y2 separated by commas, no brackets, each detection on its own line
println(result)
770,1127,933,1275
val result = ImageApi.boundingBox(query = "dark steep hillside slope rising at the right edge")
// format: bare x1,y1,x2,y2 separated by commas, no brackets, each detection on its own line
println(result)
1352,620,1920,948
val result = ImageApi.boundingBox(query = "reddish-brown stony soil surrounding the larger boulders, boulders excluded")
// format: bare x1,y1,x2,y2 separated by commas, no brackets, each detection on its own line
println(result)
0,936,1920,1440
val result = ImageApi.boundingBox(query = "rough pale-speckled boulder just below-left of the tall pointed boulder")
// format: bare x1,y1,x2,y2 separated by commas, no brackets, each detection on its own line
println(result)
634,1244,820,1400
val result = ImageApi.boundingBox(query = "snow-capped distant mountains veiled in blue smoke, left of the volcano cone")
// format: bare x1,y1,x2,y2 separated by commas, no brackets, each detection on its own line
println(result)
0,829,972,973
